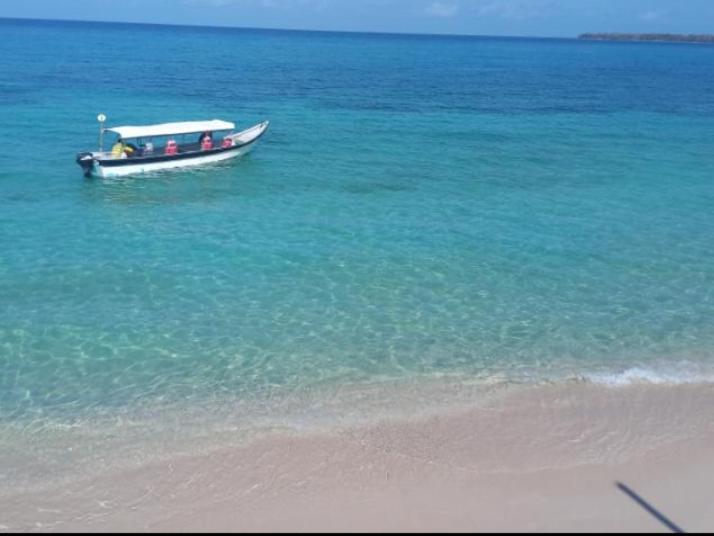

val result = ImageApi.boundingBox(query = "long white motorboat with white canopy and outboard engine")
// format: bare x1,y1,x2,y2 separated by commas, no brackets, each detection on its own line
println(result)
77,114,270,177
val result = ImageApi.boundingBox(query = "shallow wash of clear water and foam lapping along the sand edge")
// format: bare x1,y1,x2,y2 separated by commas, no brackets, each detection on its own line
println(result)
0,361,714,494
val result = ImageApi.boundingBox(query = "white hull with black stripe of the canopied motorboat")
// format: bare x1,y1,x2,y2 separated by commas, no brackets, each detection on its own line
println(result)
77,121,268,178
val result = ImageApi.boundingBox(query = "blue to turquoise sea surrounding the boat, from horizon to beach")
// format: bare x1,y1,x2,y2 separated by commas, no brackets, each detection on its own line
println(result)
0,20,714,432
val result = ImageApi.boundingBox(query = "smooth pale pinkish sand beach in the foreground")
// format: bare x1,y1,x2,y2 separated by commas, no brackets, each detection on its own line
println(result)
0,384,714,531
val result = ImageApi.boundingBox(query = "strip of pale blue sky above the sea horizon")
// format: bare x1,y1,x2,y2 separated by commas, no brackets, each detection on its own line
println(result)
0,0,714,37
